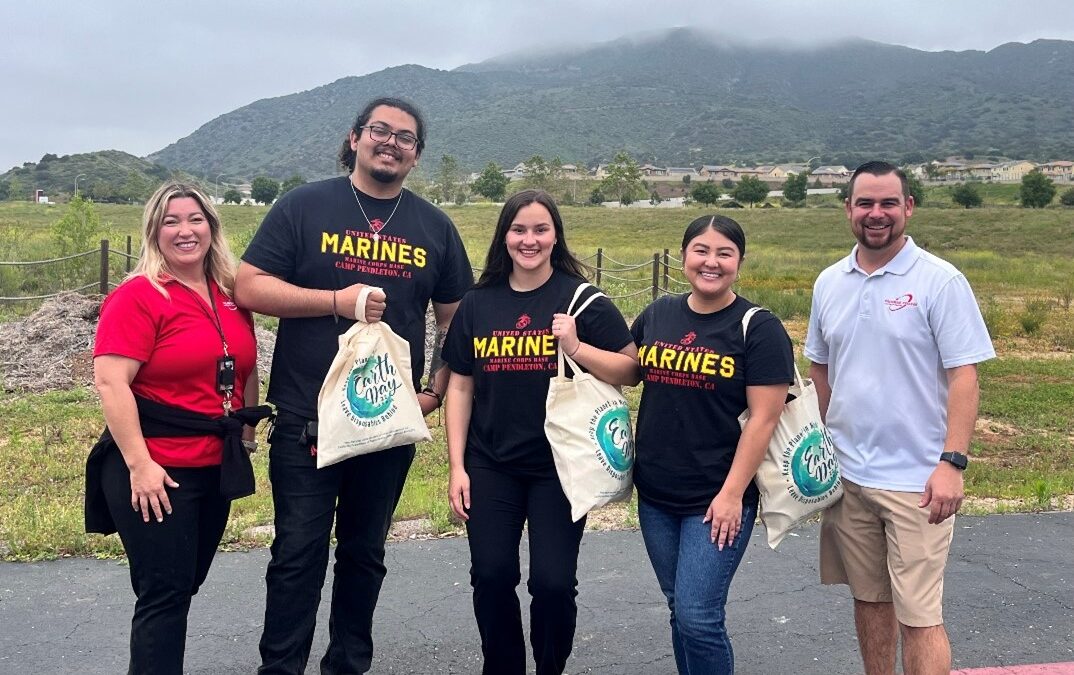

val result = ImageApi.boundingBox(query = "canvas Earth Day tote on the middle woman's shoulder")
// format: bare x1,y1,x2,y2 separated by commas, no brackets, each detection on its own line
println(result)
545,284,634,522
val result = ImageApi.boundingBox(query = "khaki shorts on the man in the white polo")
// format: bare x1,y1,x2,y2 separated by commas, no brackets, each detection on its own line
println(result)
821,479,955,628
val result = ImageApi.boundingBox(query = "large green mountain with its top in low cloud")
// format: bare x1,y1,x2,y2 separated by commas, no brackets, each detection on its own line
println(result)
149,29,1074,178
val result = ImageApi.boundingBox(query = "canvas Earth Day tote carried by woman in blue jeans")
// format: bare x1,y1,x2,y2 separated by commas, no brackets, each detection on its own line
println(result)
739,307,843,548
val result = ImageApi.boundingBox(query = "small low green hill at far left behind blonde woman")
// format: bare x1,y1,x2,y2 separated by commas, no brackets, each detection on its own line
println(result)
0,150,193,202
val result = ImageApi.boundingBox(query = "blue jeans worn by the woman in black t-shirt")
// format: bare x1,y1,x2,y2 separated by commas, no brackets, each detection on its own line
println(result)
638,498,757,675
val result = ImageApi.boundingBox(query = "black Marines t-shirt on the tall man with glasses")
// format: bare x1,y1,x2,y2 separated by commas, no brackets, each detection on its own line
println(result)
243,176,474,418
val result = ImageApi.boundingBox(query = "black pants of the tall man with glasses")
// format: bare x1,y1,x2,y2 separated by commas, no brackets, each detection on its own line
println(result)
258,411,415,675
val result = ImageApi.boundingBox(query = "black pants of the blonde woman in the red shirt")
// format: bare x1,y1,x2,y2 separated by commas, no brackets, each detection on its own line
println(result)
101,444,231,675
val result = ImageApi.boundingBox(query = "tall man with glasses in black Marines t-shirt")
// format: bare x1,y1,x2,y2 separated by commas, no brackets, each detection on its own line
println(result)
235,99,473,674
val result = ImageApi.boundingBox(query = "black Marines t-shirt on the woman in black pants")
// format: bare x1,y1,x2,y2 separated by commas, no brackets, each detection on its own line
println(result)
444,271,632,474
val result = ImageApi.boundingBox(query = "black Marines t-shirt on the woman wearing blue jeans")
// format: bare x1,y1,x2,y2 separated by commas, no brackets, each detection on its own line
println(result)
630,295,794,515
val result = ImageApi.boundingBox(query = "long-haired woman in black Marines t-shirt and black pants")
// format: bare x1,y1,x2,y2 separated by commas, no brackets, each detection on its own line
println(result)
444,190,637,675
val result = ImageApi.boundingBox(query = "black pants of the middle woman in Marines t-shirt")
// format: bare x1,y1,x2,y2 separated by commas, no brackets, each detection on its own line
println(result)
466,466,585,675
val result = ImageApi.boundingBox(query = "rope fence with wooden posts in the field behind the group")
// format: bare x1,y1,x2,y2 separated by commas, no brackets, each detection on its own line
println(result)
0,236,690,303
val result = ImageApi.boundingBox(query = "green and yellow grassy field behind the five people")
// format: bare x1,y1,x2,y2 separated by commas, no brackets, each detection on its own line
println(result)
0,199,1074,560
